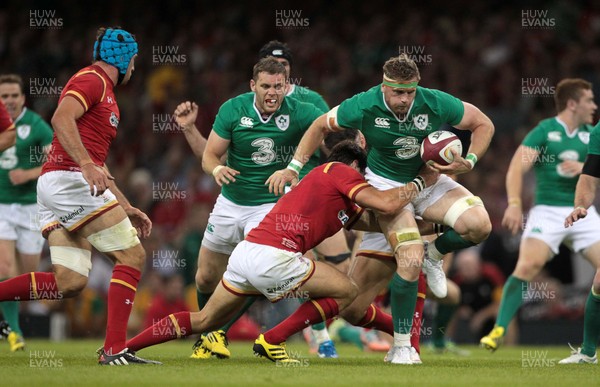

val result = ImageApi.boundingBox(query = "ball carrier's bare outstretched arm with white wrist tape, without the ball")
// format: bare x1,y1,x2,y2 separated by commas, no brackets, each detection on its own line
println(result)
265,114,333,195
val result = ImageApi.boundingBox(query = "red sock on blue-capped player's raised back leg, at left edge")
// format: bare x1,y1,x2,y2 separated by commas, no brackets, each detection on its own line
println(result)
0,272,62,301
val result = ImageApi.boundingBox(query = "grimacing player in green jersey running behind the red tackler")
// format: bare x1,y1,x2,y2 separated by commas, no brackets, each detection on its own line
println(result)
189,58,322,358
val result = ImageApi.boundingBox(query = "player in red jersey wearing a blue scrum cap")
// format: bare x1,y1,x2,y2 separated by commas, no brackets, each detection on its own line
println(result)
0,28,156,365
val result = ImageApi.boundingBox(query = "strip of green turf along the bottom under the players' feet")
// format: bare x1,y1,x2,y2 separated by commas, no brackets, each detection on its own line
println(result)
0,340,600,387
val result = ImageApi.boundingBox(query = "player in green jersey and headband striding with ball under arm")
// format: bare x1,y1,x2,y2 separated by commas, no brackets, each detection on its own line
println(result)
267,54,494,364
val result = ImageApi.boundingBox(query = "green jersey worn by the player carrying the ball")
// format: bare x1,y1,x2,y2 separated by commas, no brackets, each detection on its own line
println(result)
337,85,464,183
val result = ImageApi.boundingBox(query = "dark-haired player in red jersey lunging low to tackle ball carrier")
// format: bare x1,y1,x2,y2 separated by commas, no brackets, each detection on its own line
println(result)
127,141,438,363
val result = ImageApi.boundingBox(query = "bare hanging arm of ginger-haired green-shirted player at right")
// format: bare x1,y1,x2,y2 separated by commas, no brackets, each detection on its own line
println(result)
502,145,539,235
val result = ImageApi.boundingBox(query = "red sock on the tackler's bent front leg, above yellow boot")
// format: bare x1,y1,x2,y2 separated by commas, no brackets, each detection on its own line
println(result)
265,298,339,344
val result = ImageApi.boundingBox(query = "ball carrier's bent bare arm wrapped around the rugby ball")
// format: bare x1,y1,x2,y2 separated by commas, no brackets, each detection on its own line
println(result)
435,102,494,175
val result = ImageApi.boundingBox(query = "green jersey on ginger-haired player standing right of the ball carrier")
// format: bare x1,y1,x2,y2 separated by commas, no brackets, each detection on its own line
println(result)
522,117,591,206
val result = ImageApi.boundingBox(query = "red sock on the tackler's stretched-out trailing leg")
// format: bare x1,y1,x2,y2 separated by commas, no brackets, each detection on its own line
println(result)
125,312,192,351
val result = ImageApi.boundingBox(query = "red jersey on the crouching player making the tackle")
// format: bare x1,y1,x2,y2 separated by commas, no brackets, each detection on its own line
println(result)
246,162,369,253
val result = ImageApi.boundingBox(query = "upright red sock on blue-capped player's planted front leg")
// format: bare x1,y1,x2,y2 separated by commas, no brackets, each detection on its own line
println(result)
104,265,141,355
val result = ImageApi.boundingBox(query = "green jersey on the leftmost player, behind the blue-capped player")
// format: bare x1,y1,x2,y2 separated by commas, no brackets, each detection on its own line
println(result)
0,108,54,204
